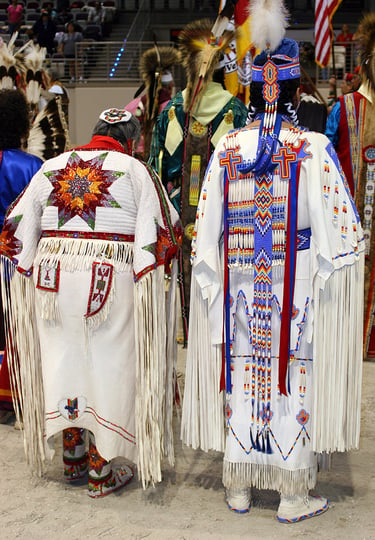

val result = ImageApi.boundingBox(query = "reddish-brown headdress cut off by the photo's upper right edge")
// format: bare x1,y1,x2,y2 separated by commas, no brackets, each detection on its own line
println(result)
355,13,375,92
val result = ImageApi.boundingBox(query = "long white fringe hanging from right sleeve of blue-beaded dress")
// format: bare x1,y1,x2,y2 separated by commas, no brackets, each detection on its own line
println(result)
312,253,364,452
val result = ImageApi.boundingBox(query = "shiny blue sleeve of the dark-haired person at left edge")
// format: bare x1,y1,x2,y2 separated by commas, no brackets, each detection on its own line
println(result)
0,150,43,229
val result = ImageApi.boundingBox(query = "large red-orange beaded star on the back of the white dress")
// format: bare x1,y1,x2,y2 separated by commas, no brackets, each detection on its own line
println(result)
45,152,124,230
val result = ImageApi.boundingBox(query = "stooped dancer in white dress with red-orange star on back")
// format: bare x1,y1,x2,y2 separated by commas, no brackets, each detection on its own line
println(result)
0,109,181,497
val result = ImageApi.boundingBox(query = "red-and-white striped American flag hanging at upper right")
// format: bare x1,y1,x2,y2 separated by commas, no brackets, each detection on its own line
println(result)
315,0,342,67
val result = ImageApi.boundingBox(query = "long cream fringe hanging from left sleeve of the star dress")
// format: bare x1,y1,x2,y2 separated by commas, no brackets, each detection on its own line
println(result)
0,256,45,476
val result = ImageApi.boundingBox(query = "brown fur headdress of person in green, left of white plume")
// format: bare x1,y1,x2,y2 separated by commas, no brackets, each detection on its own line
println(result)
179,19,235,112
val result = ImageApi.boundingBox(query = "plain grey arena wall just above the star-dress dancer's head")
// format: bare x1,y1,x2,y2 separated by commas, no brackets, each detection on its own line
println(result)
67,84,138,146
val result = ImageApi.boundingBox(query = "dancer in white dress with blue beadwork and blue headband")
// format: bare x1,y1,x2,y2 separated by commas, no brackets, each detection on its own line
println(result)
182,0,364,523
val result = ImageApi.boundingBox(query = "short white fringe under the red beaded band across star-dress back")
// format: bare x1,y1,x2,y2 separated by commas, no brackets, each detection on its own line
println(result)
34,238,133,272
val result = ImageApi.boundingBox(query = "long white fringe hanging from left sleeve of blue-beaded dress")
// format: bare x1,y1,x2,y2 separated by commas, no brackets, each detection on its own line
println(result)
181,274,224,452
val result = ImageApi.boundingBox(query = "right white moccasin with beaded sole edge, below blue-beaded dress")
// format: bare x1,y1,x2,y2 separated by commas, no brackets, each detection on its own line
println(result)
276,495,328,523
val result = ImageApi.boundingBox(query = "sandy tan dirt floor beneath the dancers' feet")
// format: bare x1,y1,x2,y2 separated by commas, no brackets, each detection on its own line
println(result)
0,351,375,540
